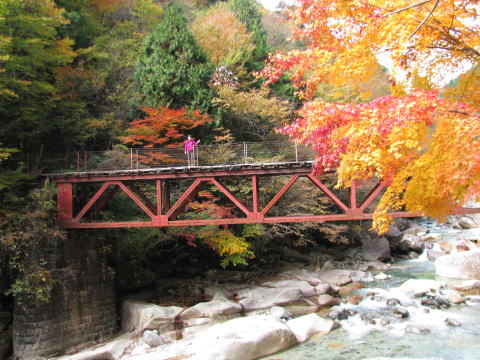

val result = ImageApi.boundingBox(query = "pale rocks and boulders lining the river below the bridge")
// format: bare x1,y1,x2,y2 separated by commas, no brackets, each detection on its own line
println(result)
56,215,480,360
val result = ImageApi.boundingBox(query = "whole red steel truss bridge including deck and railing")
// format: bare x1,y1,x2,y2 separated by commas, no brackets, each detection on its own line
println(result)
46,142,480,229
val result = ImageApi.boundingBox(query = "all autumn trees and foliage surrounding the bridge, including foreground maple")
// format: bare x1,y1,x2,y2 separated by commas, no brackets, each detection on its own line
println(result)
0,0,478,310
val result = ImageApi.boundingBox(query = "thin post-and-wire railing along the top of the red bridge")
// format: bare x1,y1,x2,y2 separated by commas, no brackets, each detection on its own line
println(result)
42,141,315,172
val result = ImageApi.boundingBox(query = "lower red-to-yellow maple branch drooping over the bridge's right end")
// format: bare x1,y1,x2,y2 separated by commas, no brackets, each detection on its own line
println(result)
281,91,480,232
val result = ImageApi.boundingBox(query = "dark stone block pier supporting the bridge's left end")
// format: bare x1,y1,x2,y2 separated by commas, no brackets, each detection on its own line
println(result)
13,231,117,359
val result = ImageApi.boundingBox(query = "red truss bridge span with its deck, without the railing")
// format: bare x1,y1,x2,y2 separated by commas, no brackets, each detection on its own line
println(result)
46,161,479,228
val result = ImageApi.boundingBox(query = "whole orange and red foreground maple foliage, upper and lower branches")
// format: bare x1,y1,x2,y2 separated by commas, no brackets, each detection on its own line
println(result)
261,0,480,232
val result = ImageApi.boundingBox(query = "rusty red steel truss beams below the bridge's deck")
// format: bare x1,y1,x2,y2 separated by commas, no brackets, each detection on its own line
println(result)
53,166,480,229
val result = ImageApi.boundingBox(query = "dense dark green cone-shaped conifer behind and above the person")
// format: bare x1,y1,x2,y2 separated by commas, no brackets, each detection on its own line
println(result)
135,4,214,113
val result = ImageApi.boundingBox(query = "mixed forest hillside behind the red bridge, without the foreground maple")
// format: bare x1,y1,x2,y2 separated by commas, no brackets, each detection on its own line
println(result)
0,0,378,306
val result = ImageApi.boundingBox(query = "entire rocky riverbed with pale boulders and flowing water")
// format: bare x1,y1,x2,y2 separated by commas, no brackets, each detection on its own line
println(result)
53,216,480,360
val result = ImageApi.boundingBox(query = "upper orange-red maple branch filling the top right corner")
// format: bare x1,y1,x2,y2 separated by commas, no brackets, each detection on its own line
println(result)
263,0,480,97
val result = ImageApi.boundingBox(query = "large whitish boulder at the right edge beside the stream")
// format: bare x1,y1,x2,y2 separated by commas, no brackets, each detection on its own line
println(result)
435,250,480,279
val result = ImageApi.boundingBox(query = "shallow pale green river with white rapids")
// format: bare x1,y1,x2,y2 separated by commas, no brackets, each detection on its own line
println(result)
263,221,480,360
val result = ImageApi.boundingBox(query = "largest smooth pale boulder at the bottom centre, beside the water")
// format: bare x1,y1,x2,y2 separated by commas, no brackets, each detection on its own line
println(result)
122,315,297,360
